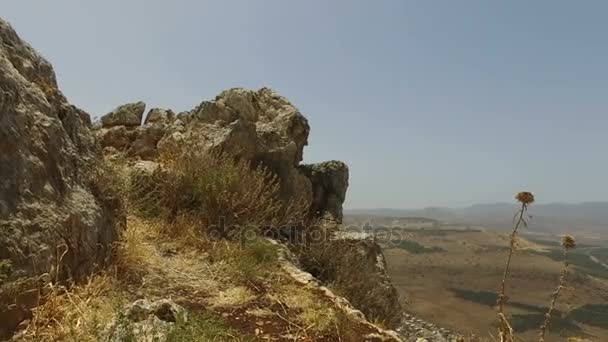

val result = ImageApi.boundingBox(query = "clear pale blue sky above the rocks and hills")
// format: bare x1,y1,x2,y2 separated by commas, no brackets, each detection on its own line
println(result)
0,0,608,208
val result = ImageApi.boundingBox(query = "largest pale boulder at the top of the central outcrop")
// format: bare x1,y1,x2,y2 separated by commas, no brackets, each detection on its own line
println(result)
158,88,312,202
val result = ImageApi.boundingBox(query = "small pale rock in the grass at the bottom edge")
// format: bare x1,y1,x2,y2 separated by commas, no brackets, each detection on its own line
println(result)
102,299,187,342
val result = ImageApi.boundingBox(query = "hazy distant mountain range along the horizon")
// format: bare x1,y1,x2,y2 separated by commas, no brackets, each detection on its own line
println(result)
345,202,608,236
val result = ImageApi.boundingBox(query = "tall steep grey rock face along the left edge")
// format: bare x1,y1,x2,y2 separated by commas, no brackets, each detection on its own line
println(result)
0,19,124,335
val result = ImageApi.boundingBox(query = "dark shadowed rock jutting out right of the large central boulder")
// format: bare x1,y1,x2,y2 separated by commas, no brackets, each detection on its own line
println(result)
301,160,348,223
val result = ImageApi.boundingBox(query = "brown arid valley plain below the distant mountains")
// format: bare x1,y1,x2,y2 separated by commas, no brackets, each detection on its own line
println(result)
345,214,608,341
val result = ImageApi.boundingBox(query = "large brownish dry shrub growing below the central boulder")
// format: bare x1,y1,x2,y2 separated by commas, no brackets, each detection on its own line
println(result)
131,139,309,237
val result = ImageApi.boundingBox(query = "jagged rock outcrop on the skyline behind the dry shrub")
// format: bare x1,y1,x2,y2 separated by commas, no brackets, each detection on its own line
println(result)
97,88,348,222
